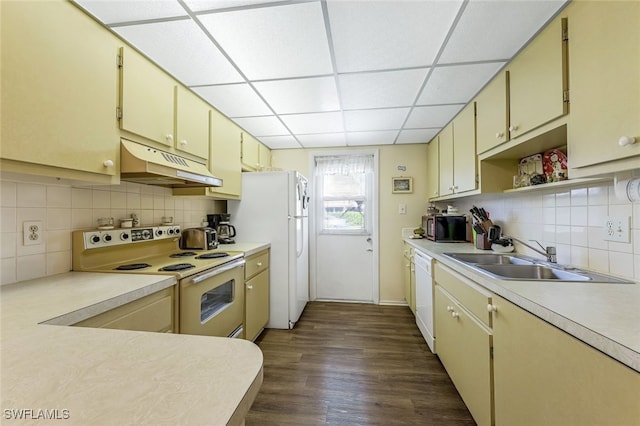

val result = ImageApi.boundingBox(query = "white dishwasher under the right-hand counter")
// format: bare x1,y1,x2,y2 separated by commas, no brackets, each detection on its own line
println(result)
413,250,436,353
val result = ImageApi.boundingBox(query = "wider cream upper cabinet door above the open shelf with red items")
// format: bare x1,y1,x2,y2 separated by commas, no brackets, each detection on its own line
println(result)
508,18,573,139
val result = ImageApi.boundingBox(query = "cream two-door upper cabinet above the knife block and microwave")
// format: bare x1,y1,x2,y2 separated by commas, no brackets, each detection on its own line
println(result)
438,102,476,197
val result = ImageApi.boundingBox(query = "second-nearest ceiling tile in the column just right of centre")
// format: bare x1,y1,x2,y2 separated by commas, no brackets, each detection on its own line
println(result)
339,68,427,109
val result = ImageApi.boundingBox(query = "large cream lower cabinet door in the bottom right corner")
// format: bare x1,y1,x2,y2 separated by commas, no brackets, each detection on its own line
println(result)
492,297,640,426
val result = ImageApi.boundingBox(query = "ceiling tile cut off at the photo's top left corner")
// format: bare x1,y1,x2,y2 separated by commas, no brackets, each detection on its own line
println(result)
75,0,187,24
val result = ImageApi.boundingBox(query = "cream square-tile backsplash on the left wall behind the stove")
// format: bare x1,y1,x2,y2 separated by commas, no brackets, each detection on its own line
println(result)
0,177,221,285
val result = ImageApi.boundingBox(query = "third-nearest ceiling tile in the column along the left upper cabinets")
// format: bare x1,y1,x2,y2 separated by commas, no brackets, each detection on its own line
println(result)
192,83,272,118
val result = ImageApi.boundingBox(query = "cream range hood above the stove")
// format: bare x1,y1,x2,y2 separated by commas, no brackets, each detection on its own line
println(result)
120,139,222,188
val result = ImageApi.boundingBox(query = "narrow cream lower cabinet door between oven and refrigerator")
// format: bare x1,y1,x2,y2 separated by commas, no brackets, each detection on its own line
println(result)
245,269,269,341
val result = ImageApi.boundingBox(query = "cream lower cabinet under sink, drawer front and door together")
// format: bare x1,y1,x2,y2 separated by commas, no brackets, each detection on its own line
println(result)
434,263,492,425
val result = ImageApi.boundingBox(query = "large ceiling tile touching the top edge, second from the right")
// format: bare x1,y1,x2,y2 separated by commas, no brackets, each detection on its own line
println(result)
327,0,462,72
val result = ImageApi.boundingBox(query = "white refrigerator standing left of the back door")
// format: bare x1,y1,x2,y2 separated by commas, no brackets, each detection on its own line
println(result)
227,171,309,329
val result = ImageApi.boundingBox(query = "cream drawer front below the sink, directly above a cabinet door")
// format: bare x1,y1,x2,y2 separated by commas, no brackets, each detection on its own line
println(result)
434,262,491,327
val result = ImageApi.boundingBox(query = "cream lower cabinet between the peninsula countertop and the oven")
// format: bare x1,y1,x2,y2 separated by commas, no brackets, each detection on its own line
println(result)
73,287,176,333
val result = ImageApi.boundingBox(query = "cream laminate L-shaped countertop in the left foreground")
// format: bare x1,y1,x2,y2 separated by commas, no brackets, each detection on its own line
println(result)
0,272,263,425
